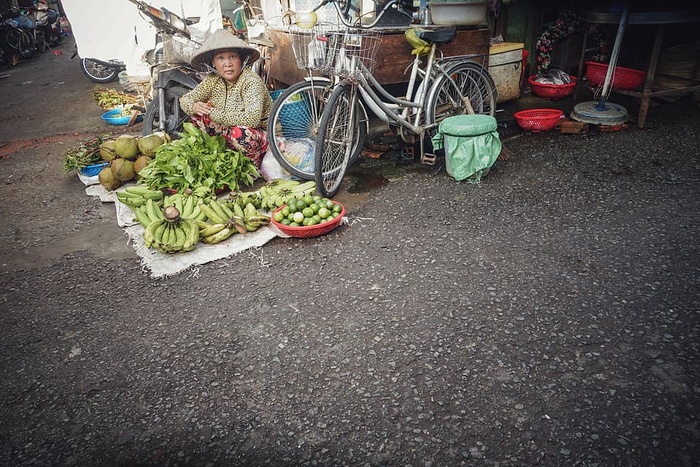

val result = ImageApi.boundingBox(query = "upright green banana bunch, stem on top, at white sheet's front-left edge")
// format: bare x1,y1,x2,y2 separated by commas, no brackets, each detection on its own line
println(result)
143,206,199,253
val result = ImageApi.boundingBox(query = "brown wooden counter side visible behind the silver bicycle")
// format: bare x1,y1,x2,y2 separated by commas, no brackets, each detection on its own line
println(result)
270,28,491,86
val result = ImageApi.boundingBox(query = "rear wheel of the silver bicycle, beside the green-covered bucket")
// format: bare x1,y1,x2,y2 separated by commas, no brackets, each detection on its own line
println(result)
425,62,497,125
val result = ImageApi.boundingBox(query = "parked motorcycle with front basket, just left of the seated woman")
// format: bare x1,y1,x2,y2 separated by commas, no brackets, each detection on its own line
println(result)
129,0,202,136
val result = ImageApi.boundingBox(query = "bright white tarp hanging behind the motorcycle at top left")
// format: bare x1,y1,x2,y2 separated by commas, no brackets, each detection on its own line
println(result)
62,0,223,76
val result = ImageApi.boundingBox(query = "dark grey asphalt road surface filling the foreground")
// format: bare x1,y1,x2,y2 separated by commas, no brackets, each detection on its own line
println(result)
0,34,700,467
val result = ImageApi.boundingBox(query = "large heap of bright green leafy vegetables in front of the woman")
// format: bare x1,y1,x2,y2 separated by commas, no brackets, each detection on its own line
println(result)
139,122,260,192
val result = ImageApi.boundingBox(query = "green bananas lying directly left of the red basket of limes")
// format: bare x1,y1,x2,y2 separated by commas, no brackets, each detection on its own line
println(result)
197,200,270,244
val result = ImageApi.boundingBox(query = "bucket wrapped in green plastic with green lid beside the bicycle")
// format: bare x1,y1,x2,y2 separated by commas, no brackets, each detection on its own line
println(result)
431,115,502,183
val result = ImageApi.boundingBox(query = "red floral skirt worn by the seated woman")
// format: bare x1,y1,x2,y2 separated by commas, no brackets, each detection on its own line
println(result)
192,115,268,168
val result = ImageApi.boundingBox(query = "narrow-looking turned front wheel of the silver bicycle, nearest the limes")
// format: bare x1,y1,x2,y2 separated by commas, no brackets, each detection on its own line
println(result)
314,83,366,198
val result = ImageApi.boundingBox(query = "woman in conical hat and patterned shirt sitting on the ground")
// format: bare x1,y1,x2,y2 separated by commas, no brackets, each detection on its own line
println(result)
180,29,272,167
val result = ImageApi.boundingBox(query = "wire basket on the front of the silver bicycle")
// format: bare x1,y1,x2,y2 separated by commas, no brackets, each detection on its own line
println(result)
321,28,382,80
